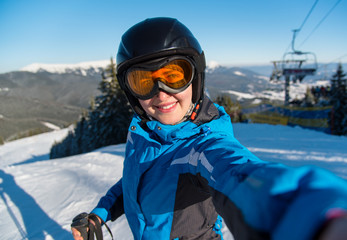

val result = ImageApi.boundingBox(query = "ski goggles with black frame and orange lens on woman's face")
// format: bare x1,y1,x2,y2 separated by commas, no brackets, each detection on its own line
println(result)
125,57,194,100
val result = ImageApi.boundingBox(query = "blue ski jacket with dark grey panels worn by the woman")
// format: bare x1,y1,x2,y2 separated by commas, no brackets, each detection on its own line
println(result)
93,98,347,240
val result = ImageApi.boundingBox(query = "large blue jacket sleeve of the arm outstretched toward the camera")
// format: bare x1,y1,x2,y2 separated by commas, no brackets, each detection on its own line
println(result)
195,138,347,240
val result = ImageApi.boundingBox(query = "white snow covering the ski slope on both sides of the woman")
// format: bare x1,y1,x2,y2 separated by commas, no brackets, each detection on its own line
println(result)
0,124,347,240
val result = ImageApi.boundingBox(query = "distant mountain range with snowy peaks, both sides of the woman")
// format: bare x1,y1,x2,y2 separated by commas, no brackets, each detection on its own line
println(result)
0,60,347,141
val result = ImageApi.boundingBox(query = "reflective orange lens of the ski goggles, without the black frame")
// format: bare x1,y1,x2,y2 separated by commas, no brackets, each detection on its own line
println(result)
127,59,193,96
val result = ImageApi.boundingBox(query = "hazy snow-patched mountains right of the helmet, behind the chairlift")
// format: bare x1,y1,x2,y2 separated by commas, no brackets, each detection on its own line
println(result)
206,61,347,104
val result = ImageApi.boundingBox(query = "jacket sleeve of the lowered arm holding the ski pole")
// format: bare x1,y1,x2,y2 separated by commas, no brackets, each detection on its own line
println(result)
92,179,124,222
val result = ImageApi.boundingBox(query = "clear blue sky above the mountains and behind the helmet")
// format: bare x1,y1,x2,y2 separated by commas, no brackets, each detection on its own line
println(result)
0,0,347,73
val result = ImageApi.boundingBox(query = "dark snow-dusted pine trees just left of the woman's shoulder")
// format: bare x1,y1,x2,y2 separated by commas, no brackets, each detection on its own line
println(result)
50,58,133,158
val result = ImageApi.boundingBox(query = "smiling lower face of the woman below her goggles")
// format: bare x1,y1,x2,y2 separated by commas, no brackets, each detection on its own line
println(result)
139,85,193,124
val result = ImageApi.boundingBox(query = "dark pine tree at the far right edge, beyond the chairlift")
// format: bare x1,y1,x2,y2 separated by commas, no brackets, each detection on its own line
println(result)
330,63,347,135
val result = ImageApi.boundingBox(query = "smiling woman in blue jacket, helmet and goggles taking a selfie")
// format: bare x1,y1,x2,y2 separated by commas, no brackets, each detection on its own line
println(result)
73,18,347,240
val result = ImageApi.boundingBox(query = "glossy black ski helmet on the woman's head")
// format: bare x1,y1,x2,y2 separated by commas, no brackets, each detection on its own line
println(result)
116,17,206,119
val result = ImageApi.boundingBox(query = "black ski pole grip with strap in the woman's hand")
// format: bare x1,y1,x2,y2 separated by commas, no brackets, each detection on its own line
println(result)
71,213,113,240
